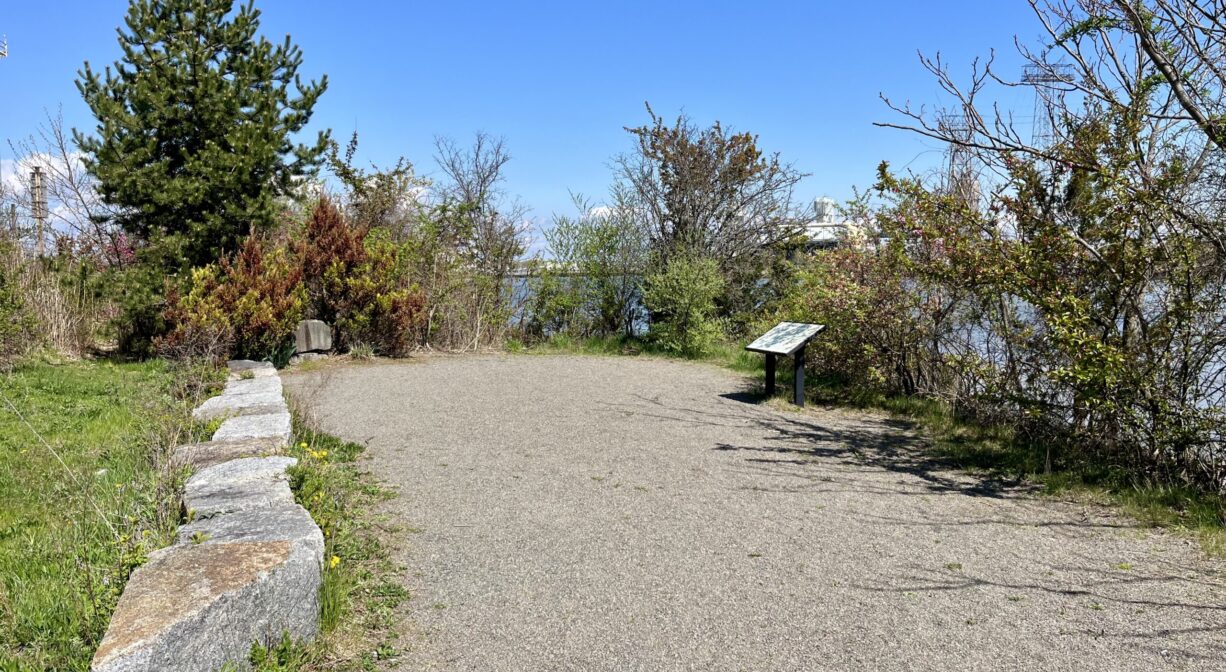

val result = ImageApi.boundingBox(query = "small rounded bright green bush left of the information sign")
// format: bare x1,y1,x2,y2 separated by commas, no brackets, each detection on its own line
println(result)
642,255,723,357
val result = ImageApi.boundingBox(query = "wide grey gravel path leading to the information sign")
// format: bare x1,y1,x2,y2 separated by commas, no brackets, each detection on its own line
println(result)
284,356,1226,671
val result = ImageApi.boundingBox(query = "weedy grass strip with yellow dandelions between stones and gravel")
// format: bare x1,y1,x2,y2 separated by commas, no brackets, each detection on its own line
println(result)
251,414,408,672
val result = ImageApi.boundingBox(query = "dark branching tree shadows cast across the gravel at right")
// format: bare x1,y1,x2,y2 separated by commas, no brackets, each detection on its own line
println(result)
595,380,1226,661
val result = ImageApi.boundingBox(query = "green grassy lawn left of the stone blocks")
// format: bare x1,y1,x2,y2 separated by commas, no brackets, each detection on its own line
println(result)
0,362,188,672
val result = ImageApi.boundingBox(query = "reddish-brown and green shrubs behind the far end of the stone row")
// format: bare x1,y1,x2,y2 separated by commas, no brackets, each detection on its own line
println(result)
159,199,424,364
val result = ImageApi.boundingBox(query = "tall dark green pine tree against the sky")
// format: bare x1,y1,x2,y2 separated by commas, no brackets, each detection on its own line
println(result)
75,0,329,271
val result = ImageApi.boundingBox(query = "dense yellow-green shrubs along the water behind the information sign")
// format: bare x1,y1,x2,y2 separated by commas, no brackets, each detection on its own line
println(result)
769,161,1226,489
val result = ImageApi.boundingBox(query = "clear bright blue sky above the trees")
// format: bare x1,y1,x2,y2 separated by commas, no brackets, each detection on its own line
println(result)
0,0,1040,230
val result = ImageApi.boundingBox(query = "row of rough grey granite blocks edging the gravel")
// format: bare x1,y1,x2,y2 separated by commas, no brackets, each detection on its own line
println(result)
91,361,324,672
